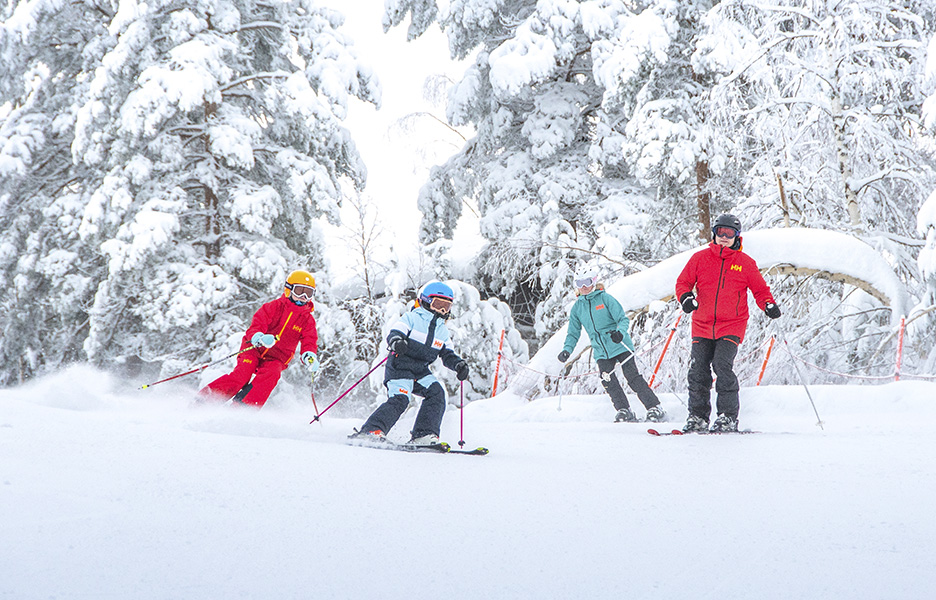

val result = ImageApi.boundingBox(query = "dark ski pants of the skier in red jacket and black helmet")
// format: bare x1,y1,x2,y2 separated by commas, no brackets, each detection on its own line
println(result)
689,335,741,421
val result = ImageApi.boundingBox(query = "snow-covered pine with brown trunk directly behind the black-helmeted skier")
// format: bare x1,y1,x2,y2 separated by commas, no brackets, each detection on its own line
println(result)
583,0,730,244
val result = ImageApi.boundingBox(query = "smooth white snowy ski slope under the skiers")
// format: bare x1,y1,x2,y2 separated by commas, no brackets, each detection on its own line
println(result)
0,369,936,600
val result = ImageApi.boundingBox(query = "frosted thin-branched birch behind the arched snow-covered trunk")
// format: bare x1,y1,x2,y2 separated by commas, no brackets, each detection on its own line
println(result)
693,0,936,373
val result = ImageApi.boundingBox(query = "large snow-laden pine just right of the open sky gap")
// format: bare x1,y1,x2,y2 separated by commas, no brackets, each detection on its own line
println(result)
385,0,672,346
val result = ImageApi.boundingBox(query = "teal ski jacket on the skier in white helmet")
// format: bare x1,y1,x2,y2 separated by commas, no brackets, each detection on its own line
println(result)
562,284,634,360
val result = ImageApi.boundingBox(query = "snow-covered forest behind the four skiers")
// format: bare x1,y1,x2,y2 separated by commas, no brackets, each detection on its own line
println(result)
0,0,936,410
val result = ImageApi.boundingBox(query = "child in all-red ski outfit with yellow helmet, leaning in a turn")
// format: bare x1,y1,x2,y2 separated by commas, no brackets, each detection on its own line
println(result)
199,271,319,408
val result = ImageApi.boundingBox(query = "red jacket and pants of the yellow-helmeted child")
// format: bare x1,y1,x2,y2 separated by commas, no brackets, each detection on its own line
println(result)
200,296,318,408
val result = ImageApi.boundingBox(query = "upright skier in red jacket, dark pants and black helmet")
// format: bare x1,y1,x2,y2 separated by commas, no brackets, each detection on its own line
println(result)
676,214,780,431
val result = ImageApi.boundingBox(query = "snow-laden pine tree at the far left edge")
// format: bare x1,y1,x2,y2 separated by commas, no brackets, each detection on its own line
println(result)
0,0,116,385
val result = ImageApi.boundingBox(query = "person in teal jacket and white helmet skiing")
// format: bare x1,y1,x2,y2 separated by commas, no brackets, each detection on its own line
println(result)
558,267,666,423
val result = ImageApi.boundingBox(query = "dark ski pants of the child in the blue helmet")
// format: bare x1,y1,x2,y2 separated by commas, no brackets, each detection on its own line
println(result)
361,375,445,438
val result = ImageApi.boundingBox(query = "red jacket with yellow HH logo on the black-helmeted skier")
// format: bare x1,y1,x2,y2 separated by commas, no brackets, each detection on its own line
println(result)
676,242,776,340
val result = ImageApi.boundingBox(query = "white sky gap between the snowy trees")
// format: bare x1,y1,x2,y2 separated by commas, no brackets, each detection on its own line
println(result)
325,0,469,279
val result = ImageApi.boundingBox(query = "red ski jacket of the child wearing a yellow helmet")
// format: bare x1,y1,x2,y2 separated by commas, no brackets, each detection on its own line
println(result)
241,296,318,365
